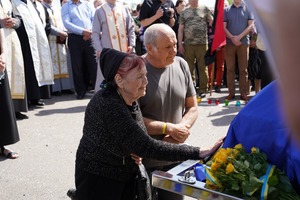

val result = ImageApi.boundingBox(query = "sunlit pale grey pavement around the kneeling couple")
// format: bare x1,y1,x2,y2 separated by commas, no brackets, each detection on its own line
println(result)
0,88,253,200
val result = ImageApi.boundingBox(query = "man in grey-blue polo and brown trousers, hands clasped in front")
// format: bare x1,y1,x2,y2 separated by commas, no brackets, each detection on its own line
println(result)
224,0,254,101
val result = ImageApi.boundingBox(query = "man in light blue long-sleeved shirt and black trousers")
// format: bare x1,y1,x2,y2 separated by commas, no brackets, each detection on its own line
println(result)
61,0,97,99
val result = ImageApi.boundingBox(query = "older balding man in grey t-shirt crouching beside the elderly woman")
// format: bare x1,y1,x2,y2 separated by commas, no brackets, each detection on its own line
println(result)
140,24,198,200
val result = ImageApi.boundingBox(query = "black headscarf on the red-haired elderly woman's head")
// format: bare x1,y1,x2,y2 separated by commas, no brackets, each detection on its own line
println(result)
100,48,128,83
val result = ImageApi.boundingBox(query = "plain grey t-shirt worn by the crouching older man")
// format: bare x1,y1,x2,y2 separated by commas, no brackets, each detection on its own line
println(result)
139,57,196,168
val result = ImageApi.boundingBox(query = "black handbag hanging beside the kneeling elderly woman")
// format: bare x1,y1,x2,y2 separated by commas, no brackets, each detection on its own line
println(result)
134,164,152,200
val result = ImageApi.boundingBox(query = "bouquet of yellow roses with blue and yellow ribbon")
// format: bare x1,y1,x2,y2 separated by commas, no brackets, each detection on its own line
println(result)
205,144,300,200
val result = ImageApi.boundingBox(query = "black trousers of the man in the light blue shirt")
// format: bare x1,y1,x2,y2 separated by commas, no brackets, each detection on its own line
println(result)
68,34,97,95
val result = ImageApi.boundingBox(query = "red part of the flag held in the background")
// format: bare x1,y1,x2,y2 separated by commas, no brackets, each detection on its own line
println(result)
211,0,226,54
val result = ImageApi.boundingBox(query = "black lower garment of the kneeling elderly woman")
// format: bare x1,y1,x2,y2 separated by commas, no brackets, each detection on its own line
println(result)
75,167,134,200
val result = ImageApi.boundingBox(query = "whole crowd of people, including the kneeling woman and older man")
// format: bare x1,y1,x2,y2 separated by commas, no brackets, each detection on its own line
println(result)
0,0,280,200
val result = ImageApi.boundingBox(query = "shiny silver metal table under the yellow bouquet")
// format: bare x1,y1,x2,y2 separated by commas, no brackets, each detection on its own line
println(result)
152,160,241,200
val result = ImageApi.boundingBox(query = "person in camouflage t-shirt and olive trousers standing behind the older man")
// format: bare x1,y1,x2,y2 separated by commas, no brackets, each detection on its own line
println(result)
179,6,212,93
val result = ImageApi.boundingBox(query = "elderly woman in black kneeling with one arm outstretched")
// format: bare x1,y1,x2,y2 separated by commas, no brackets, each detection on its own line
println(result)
69,49,222,200
